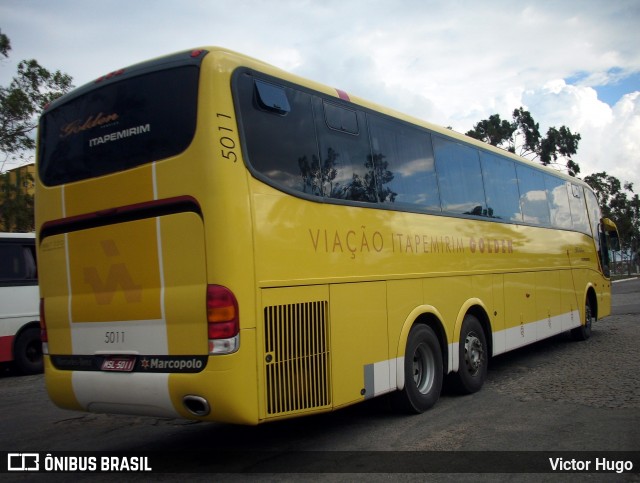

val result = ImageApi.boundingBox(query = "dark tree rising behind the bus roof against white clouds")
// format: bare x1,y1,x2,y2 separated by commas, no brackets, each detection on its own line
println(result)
466,107,580,176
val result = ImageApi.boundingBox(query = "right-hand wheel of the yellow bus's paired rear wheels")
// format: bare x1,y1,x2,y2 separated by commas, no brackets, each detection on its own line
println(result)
451,314,489,394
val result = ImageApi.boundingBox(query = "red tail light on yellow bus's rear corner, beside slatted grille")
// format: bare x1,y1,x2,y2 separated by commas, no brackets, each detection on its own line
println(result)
207,285,240,354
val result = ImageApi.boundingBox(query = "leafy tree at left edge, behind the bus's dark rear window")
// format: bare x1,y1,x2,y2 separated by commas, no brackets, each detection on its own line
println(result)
0,31,73,231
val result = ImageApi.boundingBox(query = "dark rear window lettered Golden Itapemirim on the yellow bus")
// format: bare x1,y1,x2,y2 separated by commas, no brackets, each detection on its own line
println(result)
39,65,199,186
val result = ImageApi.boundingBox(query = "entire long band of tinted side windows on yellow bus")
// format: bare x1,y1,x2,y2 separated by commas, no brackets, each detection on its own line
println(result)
234,71,600,240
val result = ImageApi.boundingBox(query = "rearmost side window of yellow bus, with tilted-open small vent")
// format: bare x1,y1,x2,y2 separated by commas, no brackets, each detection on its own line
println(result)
238,73,318,196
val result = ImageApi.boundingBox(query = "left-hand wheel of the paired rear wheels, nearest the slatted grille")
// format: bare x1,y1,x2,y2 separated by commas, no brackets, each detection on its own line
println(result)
392,324,443,414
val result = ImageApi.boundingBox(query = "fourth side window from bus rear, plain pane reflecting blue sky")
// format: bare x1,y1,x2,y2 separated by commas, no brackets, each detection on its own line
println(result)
433,136,488,216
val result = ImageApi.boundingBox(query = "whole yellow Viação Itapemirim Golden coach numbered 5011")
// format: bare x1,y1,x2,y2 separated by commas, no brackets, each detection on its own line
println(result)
36,48,616,424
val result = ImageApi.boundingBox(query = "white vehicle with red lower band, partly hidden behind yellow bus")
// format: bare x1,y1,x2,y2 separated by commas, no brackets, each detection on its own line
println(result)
0,233,42,374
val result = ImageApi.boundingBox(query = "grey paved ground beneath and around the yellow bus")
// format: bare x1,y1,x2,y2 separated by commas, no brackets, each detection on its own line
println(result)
0,280,640,481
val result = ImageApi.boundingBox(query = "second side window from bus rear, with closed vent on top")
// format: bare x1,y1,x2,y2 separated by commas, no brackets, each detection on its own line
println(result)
312,97,377,203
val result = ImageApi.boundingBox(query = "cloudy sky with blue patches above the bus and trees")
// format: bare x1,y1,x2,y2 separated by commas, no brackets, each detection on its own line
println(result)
0,0,640,192
